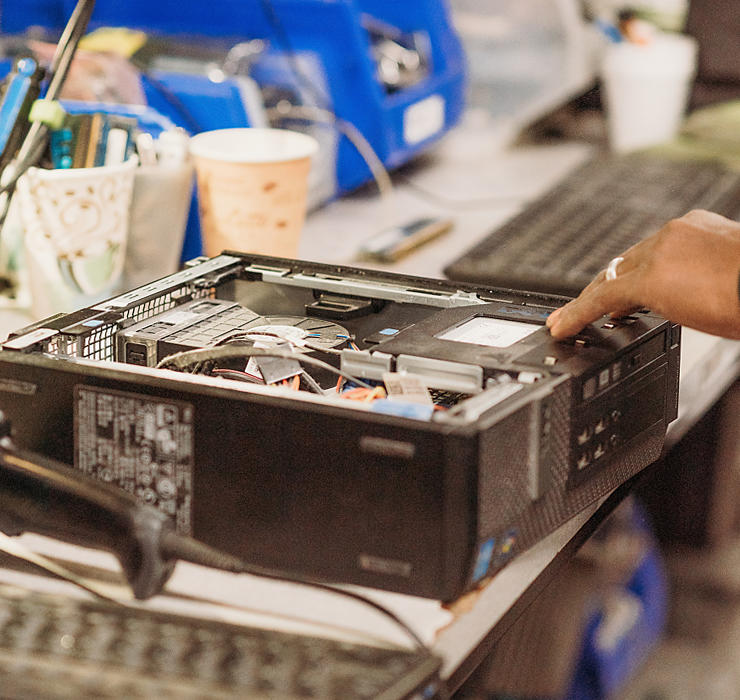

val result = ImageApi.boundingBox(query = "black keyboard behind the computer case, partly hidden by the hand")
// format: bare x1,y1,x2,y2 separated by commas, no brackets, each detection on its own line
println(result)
445,154,740,296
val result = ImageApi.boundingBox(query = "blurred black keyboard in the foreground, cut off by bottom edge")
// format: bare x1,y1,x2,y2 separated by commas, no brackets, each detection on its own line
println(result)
0,585,440,700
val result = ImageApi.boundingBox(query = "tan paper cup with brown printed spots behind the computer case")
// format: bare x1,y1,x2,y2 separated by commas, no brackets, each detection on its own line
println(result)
190,127,318,258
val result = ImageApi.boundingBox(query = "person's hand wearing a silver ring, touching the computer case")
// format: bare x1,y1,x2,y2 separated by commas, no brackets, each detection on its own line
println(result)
547,210,740,339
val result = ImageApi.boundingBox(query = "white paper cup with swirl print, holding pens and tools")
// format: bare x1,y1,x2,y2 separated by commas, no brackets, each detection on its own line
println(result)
18,157,138,319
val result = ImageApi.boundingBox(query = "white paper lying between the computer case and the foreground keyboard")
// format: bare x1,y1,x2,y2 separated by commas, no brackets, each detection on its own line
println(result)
0,534,452,647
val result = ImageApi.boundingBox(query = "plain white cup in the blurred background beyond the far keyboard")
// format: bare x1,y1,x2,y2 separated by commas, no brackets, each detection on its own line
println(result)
601,34,697,152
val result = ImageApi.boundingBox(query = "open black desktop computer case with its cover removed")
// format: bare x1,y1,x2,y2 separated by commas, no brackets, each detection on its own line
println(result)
0,253,680,600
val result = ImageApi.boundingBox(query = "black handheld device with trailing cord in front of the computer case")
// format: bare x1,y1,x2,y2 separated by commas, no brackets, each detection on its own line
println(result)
0,412,445,693
